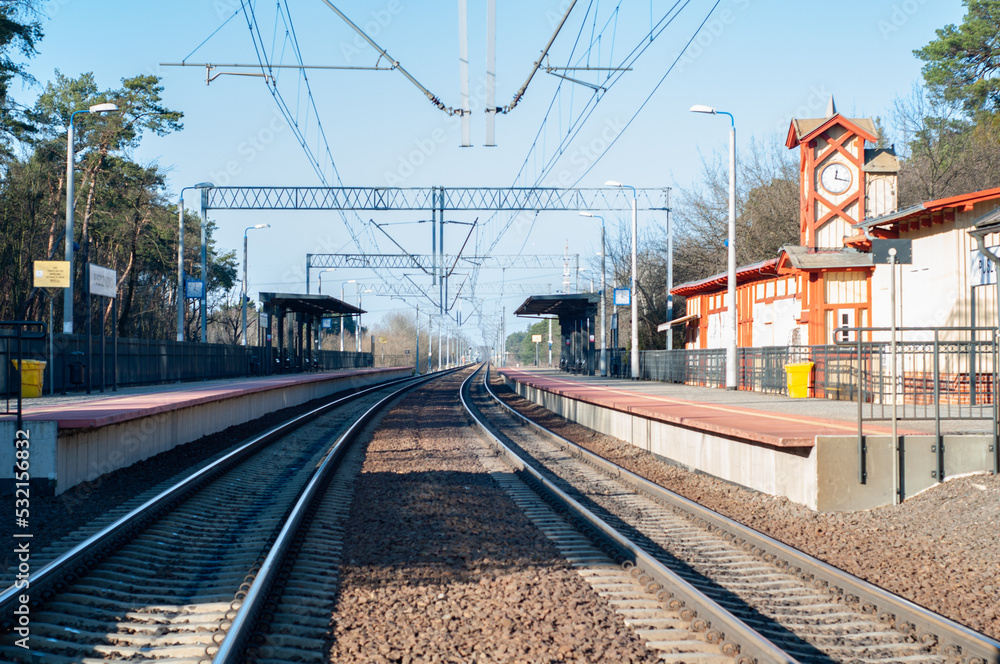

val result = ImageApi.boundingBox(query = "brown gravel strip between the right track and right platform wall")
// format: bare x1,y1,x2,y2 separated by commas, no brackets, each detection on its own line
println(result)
491,376,1000,639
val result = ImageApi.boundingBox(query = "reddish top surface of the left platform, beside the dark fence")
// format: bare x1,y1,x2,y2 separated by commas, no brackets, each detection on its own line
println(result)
0,367,408,430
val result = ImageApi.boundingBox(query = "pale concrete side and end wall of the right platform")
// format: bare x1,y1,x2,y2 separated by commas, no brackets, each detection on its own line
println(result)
504,376,993,512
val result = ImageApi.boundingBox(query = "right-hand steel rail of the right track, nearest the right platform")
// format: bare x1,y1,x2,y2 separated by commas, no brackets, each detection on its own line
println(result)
484,370,1000,664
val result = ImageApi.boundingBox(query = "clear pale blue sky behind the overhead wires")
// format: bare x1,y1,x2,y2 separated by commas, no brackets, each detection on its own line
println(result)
15,0,963,340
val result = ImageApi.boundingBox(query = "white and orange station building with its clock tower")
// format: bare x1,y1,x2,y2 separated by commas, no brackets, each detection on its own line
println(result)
671,98,1000,349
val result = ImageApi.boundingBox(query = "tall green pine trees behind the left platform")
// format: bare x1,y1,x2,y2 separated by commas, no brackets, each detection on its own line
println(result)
0,6,238,340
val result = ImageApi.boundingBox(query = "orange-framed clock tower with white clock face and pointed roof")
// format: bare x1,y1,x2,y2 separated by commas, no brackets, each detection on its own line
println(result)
785,97,876,249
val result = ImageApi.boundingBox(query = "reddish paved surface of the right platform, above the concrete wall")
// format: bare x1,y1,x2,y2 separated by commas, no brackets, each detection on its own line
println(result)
499,368,920,447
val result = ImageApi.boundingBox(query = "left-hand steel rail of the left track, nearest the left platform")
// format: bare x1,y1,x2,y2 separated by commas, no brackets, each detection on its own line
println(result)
0,376,430,619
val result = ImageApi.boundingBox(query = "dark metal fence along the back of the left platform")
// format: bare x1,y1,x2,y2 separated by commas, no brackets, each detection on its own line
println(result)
0,329,373,396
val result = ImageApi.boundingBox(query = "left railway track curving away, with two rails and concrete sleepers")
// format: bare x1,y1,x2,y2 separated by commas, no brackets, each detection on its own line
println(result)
0,368,454,663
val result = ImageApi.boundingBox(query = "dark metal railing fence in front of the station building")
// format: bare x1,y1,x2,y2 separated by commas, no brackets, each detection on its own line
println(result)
624,338,1000,419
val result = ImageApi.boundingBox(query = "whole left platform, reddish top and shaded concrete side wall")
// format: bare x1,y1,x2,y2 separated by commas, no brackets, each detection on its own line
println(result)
0,367,412,494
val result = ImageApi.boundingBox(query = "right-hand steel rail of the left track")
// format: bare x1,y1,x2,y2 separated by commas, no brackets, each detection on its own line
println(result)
212,367,465,664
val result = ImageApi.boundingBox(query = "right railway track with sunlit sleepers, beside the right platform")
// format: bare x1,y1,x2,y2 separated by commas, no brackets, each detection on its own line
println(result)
463,372,1000,664
